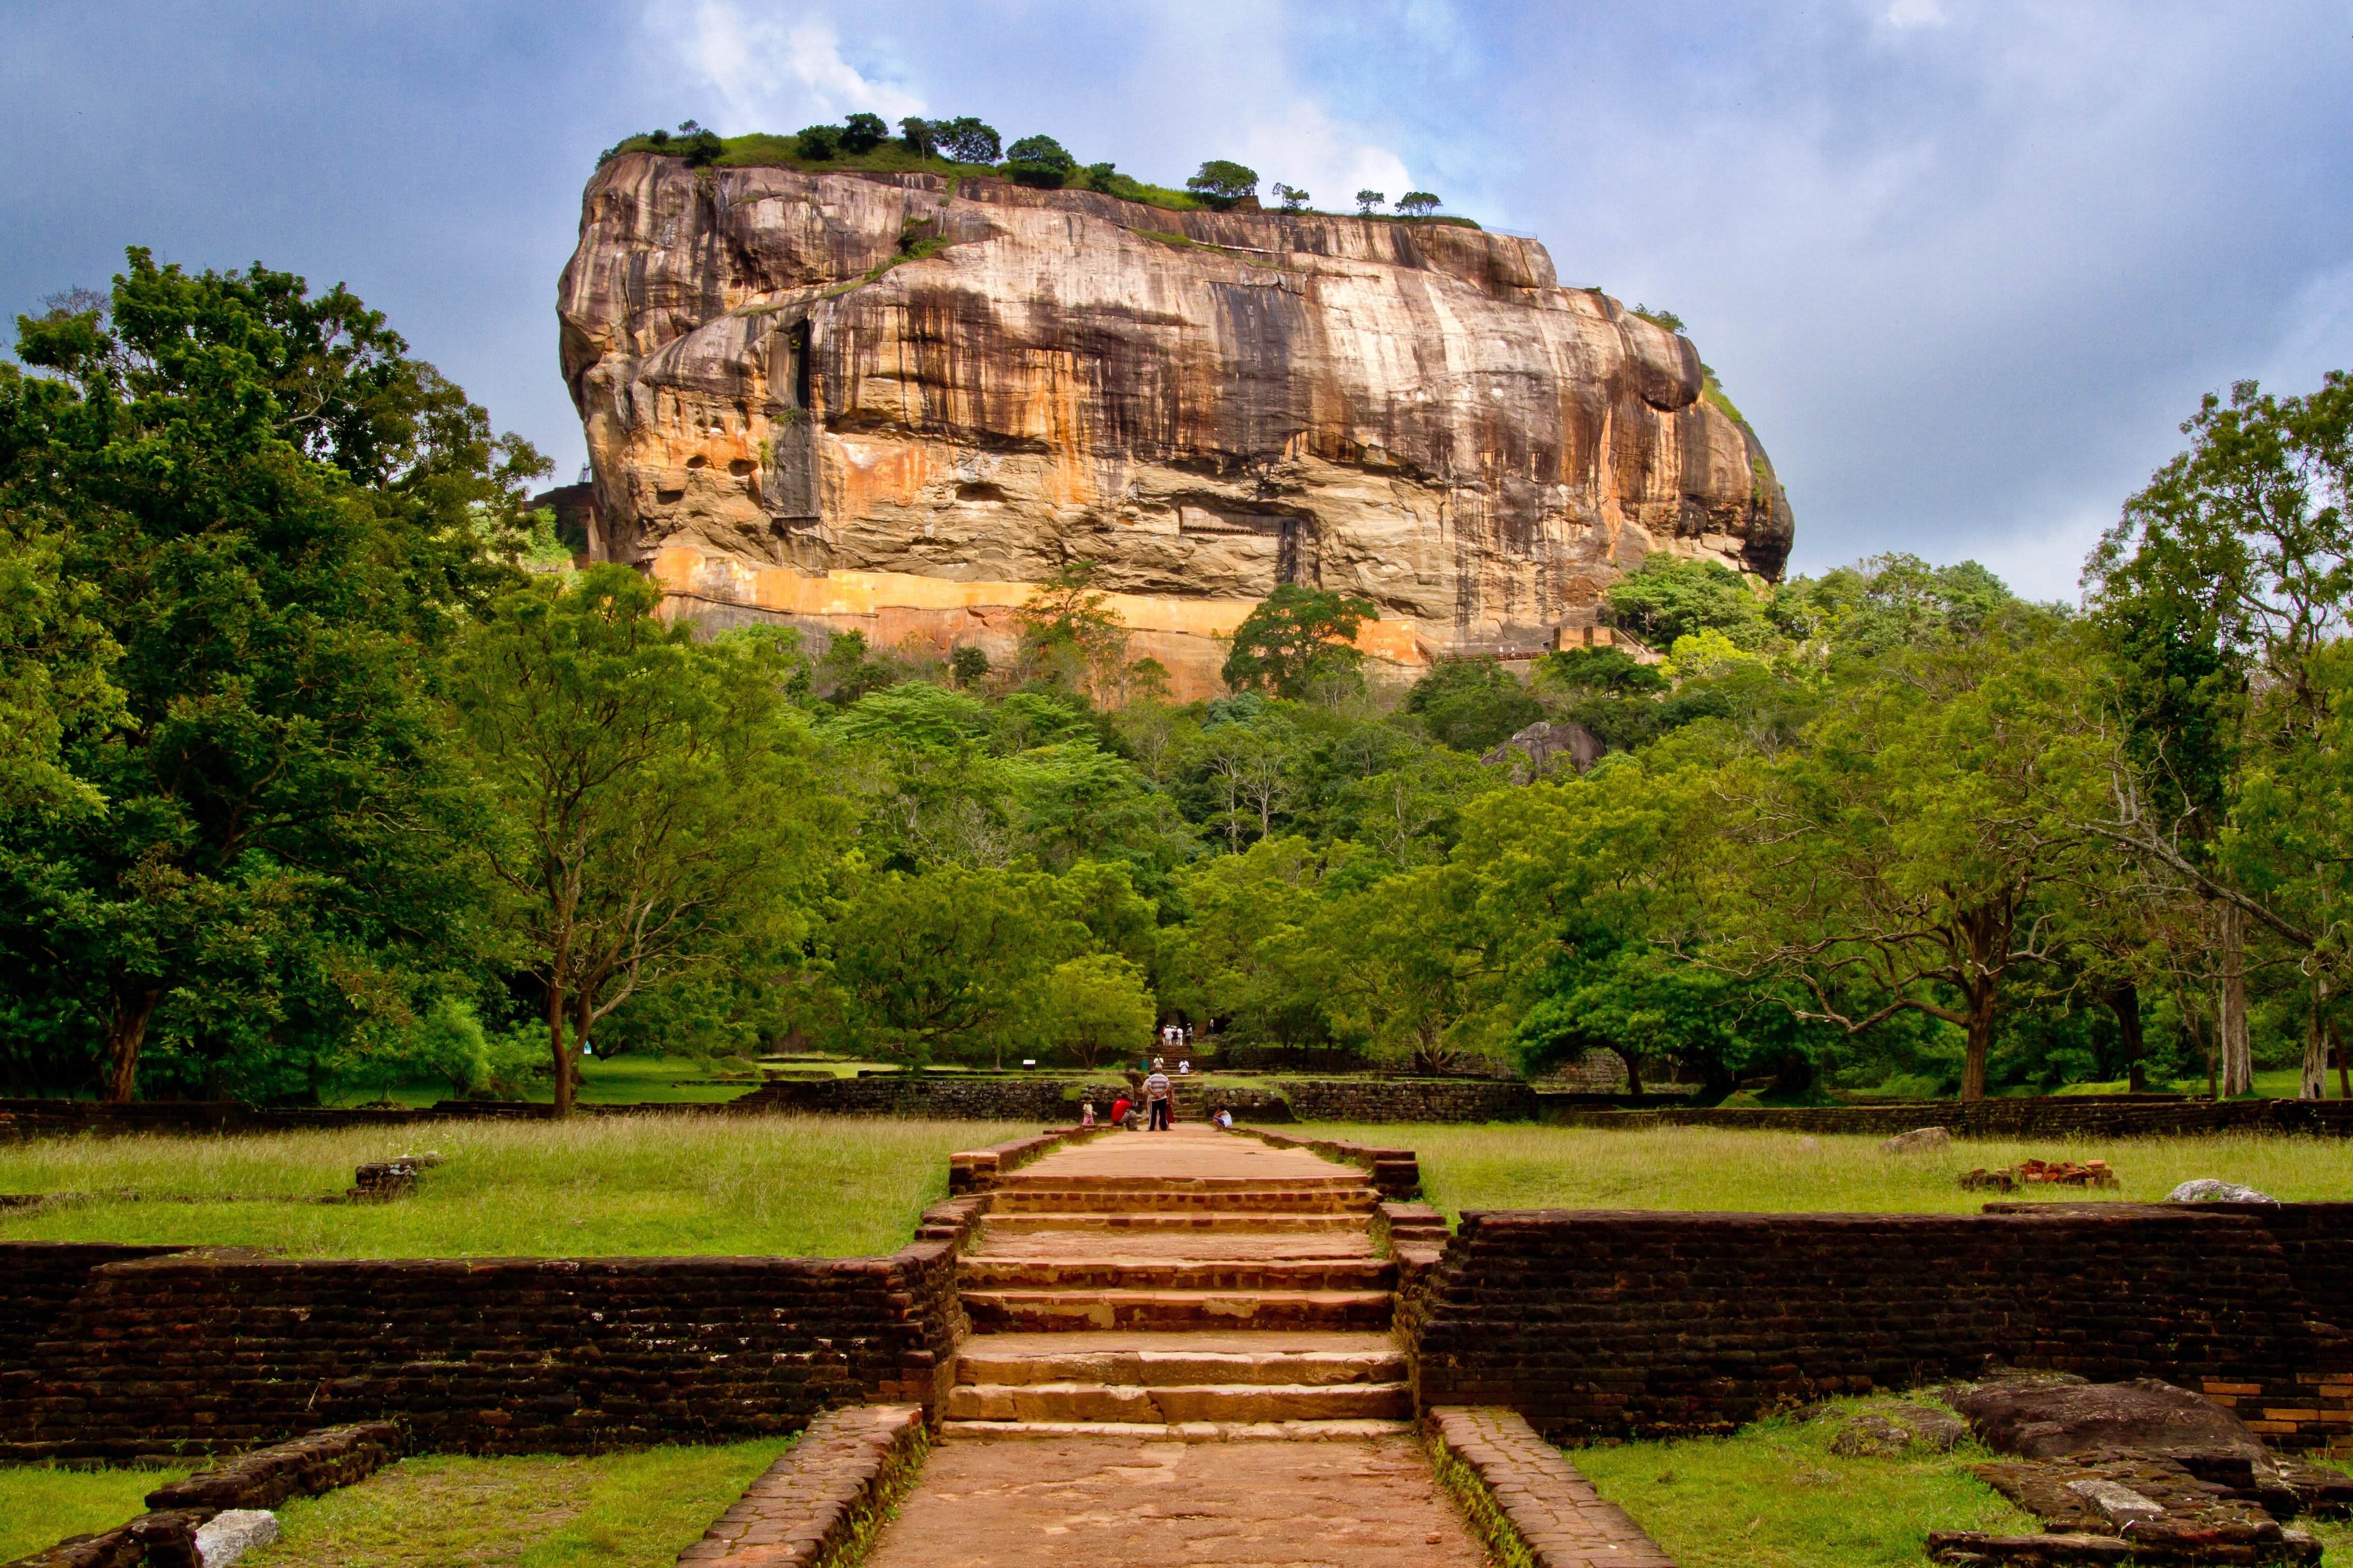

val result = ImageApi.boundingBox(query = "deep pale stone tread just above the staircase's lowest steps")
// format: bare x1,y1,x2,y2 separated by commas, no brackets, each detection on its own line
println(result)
955,1333,1405,1389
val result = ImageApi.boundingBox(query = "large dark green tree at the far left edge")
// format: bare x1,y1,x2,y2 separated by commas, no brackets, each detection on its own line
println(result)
0,249,544,1100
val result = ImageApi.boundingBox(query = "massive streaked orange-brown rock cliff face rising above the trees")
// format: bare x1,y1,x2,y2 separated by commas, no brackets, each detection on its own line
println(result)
557,153,1790,693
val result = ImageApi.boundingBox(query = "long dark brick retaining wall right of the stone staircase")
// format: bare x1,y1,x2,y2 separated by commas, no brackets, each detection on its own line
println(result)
1400,1206,2344,1441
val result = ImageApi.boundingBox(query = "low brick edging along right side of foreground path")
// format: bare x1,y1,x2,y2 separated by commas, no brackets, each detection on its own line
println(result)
1421,1406,1675,1568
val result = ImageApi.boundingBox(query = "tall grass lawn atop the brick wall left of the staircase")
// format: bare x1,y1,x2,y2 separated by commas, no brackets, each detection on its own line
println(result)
0,1114,1038,1258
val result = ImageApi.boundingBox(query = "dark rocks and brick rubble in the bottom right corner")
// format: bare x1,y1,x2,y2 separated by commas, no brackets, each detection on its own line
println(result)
1927,1375,2353,1565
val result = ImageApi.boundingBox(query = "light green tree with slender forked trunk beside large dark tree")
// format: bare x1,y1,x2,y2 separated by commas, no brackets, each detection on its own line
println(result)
450,566,845,1117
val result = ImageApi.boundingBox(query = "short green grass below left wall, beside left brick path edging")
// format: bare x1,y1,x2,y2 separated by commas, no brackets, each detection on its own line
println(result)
240,1439,793,1568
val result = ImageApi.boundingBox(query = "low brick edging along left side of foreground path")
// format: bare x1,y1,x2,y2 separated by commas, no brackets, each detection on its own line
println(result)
678,1406,927,1568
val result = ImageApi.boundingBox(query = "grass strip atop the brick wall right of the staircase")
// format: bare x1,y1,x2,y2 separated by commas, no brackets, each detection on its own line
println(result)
1285,1114,2353,1218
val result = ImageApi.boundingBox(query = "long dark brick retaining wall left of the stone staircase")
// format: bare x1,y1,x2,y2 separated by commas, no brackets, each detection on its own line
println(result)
0,1199,977,1458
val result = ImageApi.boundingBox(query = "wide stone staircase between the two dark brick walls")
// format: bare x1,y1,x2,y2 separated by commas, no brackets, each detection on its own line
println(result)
941,1126,1412,1441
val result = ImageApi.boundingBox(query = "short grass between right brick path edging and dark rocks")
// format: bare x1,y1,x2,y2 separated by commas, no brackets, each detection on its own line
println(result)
1567,1399,2353,1568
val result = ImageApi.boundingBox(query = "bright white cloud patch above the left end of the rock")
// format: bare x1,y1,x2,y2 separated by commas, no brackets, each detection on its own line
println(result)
663,0,922,134
